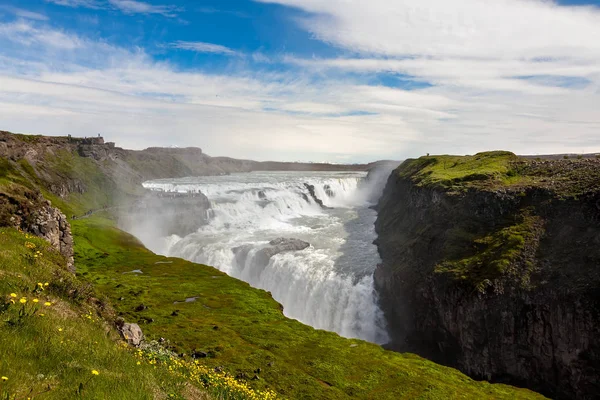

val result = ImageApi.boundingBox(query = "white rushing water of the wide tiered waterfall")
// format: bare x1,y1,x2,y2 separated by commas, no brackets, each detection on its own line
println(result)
144,172,388,343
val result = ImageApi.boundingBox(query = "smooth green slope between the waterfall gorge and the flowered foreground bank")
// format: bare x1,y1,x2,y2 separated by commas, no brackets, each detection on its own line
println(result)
73,217,541,399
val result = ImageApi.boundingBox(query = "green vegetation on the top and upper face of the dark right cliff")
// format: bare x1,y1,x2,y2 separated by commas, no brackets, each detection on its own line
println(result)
397,151,600,291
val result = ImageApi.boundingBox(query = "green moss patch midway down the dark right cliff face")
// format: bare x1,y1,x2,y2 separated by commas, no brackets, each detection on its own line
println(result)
435,215,541,291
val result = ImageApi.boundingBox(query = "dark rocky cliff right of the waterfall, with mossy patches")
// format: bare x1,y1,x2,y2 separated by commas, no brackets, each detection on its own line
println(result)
375,154,600,399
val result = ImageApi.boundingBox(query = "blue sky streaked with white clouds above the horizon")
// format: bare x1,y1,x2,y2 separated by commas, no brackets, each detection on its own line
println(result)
0,0,600,163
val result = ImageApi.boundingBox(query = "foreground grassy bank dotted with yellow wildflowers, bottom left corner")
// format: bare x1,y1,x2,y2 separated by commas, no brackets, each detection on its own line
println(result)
0,228,271,400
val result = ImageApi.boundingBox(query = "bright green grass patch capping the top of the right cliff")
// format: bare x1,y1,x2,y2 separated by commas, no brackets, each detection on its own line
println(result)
397,151,518,189
